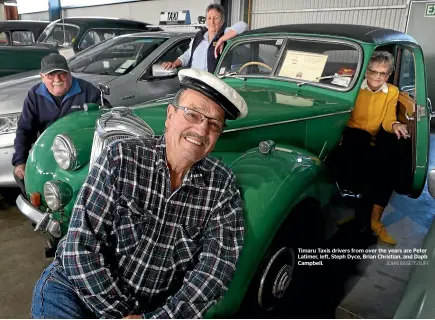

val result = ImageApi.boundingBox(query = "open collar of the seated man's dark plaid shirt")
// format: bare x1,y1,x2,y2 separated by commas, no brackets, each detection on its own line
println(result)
155,135,209,187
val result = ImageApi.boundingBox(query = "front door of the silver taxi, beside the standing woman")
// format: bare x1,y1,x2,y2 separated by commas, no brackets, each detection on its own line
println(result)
137,38,191,101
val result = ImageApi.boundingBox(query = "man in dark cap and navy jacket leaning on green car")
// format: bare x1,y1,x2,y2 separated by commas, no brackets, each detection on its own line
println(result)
12,53,101,195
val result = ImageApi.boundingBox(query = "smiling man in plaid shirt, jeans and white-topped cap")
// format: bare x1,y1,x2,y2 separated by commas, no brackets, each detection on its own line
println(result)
32,69,247,319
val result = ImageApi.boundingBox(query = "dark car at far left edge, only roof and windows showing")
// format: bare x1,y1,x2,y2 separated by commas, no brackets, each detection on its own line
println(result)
0,20,50,46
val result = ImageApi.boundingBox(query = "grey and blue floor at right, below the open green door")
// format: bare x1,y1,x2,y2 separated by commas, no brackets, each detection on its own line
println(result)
340,134,435,318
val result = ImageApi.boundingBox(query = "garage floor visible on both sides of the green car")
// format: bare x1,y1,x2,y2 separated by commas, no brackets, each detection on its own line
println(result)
0,134,435,318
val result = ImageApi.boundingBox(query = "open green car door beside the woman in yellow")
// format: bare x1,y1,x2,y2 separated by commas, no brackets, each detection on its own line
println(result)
394,45,431,198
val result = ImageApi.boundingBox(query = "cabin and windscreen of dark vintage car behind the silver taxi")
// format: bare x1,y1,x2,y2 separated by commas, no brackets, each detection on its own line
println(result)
37,17,162,58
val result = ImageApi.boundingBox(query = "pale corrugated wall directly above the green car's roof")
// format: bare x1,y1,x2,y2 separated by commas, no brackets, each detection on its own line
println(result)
251,0,409,31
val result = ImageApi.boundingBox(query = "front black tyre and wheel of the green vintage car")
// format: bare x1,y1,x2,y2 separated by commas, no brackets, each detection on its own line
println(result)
236,201,324,318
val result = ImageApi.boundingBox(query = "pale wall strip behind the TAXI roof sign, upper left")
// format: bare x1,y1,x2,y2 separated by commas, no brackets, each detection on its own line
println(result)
64,0,220,25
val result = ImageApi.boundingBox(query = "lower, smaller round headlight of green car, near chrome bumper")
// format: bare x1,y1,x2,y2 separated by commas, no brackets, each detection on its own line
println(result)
44,180,72,211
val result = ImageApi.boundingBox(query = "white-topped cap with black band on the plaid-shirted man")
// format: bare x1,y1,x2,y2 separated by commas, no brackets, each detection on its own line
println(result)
178,69,248,120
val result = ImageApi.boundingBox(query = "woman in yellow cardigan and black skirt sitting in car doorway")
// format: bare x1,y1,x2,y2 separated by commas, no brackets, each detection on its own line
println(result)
340,51,409,244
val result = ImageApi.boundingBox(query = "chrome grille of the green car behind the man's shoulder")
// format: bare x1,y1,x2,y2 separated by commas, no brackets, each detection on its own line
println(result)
89,107,154,171
